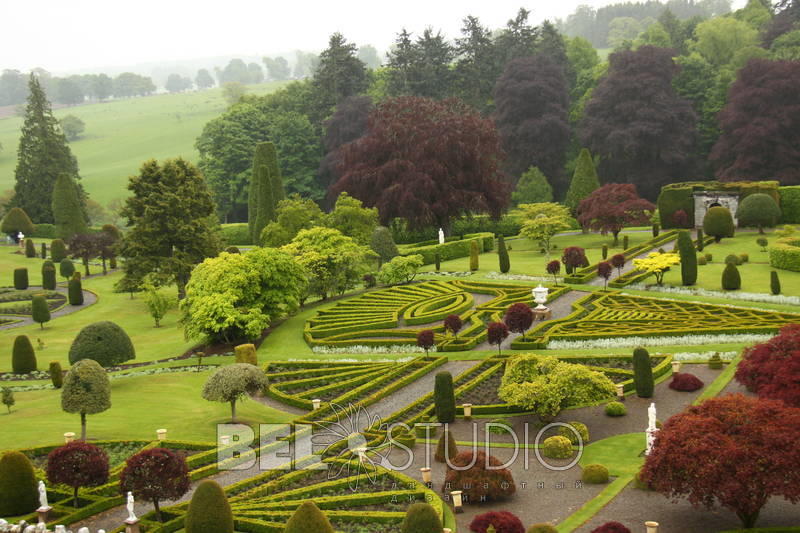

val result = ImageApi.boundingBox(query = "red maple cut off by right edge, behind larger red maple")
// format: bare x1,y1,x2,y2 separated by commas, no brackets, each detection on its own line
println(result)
736,324,800,407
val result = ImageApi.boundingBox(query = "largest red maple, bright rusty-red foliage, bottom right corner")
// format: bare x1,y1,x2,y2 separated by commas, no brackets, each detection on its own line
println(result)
641,394,800,528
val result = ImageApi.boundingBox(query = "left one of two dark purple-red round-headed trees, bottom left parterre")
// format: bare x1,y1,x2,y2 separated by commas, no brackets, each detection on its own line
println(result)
47,441,108,508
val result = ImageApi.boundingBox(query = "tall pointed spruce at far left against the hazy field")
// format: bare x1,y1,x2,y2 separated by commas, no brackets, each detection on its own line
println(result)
12,74,83,224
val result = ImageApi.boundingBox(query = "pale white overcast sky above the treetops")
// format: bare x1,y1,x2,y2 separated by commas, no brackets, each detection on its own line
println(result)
0,0,745,73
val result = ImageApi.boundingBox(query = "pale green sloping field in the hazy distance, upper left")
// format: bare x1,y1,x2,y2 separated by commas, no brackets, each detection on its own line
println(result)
0,82,283,206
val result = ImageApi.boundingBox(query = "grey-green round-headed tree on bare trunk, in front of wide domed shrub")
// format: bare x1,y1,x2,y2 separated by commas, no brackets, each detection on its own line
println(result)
61,359,111,440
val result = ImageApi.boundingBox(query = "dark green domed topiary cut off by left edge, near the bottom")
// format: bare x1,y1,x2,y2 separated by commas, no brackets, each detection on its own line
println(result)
0,451,39,517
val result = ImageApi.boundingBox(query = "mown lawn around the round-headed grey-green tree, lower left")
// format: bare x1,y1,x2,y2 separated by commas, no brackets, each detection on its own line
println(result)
0,372,295,449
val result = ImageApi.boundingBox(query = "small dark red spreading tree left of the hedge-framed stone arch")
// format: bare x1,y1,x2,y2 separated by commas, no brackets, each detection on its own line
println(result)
578,183,656,246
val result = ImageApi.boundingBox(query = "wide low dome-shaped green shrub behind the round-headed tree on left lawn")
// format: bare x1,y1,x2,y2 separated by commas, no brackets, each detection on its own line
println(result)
69,321,136,367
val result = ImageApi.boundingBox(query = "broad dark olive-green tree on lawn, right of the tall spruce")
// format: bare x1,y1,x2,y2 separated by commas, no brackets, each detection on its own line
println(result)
119,158,221,296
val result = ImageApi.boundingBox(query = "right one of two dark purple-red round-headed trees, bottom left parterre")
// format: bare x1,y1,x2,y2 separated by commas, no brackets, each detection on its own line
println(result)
119,448,190,522
